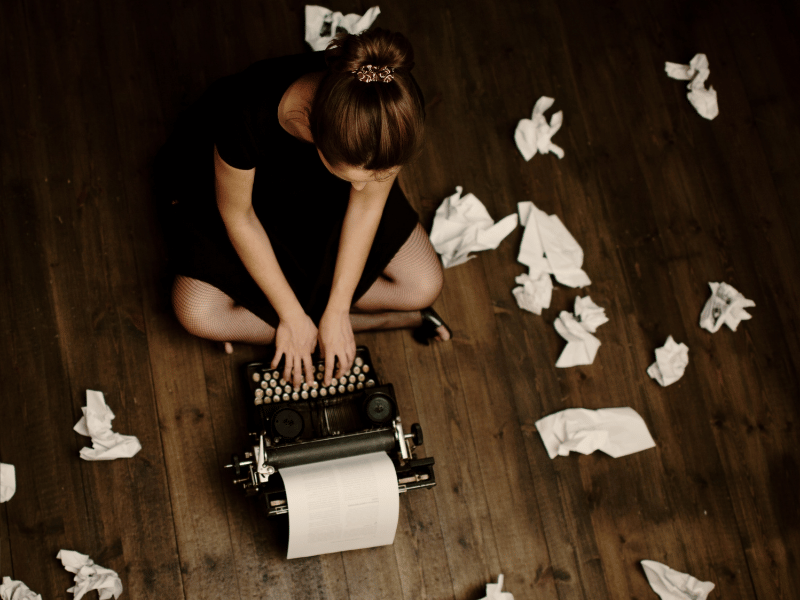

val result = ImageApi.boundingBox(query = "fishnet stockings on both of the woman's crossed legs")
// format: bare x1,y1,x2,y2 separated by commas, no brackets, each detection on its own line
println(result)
172,224,444,344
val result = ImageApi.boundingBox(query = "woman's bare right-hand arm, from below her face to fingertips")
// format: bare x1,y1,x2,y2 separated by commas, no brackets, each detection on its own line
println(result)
319,174,397,385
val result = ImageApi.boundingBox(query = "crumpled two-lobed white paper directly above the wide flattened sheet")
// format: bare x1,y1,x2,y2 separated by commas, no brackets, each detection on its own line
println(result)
553,296,608,369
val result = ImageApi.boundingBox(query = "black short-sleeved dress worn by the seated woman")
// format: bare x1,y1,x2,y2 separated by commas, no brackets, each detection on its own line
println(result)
156,52,418,327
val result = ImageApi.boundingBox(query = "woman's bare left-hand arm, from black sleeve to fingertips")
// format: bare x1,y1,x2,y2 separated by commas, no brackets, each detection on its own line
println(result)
214,147,317,386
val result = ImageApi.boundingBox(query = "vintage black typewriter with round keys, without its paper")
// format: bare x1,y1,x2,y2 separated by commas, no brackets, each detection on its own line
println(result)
225,346,436,517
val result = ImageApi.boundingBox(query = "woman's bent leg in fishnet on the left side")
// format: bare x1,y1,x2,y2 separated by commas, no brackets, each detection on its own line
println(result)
172,275,275,352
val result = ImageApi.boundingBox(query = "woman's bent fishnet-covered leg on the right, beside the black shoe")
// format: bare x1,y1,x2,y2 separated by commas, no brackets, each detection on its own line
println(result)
350,223,450,340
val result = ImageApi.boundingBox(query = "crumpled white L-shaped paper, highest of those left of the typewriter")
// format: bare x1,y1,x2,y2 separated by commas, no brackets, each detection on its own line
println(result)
73,390,142,460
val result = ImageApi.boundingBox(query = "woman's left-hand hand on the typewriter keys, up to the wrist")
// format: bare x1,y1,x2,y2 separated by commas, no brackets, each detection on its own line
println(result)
272,312,317,388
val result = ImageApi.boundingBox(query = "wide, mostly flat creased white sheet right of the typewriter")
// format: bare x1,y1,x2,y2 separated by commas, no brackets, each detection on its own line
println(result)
536,406,656,458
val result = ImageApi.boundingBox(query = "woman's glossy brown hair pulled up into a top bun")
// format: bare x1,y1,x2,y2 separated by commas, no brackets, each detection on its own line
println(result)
309,29,425,171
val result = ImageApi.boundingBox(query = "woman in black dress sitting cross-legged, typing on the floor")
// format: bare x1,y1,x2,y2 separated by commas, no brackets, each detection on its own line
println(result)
159,29,451,386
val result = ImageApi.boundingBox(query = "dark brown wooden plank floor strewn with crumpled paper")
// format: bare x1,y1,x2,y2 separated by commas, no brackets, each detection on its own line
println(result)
0,0,800,600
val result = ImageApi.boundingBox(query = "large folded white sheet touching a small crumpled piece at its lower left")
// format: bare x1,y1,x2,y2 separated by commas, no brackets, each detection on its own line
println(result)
517,201,592,288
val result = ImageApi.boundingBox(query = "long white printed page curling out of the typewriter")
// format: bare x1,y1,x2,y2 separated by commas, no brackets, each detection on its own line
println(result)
280,452,400,558
